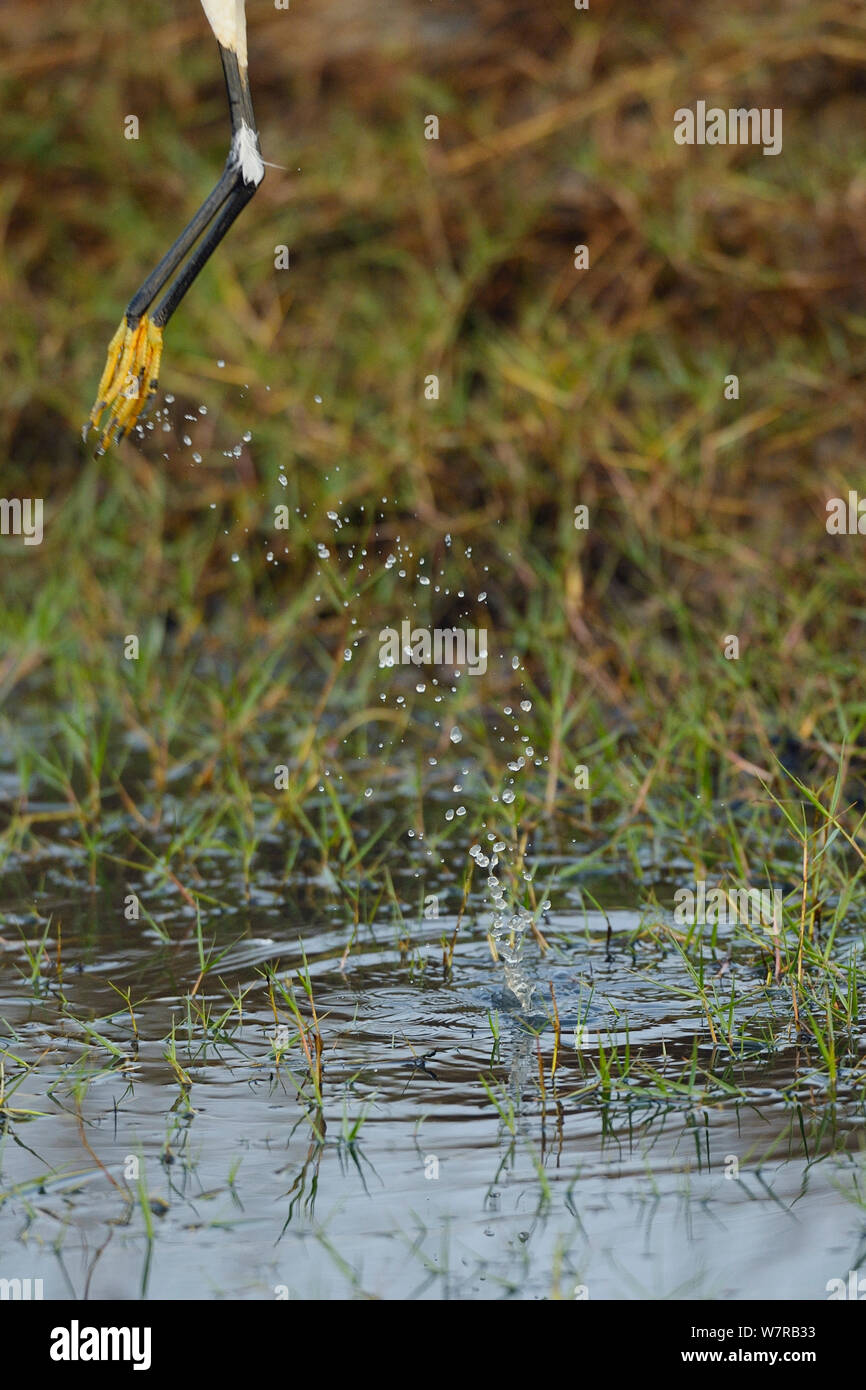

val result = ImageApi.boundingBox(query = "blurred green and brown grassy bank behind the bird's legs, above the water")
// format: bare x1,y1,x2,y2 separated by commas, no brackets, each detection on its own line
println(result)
0,0,866,845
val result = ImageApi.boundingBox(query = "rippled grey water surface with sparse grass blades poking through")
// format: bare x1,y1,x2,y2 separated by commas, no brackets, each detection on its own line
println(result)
0,834,866,1300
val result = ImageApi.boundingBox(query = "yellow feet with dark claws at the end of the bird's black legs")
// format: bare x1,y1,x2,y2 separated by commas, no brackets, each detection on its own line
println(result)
83,317,163,453
